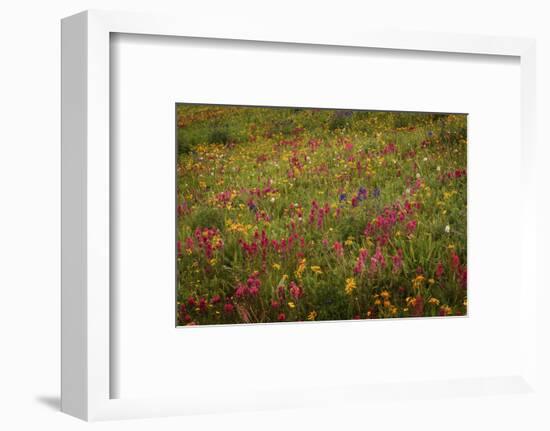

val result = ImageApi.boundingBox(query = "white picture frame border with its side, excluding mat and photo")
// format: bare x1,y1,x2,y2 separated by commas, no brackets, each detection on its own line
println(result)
61,11,544,420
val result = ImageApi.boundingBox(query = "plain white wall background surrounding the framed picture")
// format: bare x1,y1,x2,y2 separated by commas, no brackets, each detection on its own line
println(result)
0,0,550,430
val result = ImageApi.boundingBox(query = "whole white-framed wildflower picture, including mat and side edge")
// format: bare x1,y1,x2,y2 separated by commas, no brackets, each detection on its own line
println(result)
62,11,545,427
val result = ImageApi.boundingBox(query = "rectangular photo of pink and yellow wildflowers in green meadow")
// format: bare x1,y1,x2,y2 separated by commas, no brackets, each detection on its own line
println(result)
176,104,467,325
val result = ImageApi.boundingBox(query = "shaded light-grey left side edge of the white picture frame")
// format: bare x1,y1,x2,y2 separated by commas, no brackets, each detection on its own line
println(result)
61,12,88,420
